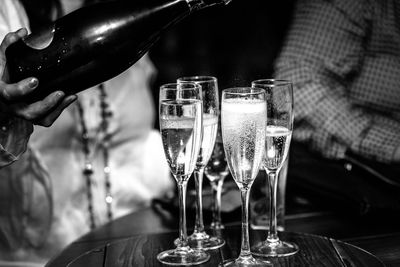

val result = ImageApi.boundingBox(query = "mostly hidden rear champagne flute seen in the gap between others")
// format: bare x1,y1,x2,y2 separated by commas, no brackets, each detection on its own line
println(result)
204,123,229,231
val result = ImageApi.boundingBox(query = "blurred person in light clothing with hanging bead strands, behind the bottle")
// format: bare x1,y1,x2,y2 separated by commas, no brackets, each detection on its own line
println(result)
0,0,174,266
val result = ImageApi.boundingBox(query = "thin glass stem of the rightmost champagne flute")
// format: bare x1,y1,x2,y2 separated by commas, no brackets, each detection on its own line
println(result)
267,171,279,243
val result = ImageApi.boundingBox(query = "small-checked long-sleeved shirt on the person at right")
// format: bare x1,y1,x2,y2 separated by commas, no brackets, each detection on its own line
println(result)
275,0,400,163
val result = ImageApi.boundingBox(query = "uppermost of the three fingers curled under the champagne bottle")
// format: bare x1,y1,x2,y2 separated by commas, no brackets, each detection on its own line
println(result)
0,77,39,102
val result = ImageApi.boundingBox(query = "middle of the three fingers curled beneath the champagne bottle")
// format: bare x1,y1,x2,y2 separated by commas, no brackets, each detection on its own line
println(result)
14,91,65,121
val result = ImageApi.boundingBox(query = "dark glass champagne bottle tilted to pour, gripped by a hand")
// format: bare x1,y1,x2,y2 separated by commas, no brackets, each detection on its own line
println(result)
6,0,231,102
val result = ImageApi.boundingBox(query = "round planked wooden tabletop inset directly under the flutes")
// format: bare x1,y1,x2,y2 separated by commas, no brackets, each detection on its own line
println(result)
58,230,384,267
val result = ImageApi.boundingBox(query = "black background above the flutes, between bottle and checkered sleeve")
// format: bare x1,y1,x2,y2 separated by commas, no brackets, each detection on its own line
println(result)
149,0,295,128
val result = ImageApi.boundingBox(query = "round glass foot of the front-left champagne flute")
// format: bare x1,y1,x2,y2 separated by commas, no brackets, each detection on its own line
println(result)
157,247,210,266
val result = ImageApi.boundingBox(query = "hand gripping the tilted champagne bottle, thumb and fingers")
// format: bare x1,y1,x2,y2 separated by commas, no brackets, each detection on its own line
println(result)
0,29,77,127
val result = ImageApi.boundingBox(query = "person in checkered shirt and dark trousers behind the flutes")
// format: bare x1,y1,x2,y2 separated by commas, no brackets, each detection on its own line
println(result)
275,0,400,214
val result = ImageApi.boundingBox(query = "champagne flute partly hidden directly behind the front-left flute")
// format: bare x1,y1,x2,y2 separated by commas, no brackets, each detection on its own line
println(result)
177,76,225,250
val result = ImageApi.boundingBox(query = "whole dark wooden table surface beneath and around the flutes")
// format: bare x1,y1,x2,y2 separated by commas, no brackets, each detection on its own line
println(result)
46,209,400,267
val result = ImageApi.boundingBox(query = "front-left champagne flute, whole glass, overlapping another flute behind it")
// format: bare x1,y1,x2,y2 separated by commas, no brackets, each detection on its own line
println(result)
157,83,210,266
